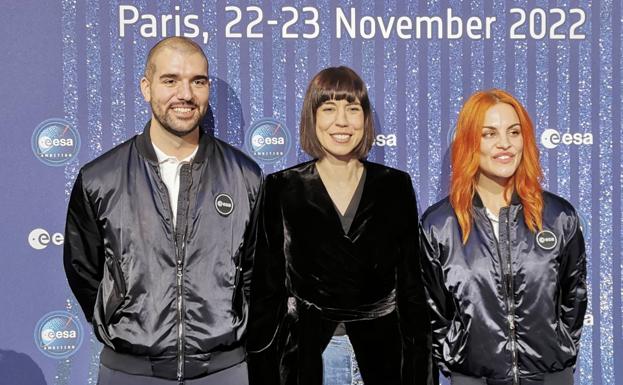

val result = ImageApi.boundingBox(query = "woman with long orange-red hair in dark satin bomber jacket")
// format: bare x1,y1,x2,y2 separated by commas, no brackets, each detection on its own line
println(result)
421,89,586,385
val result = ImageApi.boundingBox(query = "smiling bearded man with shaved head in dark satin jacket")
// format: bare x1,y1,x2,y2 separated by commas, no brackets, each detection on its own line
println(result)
64,37,262,385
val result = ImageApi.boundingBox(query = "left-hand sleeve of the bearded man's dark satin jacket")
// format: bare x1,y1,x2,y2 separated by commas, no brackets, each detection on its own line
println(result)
63,173,104,322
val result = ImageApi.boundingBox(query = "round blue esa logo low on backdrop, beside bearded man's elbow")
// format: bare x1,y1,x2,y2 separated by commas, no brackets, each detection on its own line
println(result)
35,311,83,358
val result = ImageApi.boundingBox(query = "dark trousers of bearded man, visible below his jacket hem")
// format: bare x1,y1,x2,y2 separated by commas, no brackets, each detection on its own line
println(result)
97,362,248,385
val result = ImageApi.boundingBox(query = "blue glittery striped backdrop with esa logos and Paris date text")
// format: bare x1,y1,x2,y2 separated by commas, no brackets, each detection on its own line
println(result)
0,0,623,385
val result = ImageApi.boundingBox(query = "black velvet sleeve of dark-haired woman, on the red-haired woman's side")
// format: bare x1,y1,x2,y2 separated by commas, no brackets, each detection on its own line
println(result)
397,175,437,385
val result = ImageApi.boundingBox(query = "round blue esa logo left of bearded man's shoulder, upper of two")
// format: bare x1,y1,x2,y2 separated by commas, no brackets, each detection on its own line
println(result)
31,118,80,166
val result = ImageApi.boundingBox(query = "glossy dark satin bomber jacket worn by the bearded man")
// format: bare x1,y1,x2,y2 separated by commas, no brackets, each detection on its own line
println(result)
64,127,261,378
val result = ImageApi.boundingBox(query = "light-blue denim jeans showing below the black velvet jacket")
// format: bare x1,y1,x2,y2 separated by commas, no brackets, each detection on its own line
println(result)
322,335,363,385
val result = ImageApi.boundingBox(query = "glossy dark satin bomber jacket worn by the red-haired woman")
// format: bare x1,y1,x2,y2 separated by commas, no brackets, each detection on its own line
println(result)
422,192,587,384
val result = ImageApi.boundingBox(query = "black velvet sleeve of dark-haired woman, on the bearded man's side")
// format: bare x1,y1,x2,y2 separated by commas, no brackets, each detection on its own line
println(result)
247,176,287,385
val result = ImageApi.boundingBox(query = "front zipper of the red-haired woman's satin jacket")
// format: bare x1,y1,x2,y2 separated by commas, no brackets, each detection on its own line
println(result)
488,210,519,385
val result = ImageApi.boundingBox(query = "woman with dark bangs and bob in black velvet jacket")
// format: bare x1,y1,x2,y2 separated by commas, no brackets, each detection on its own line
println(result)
247,67,432,385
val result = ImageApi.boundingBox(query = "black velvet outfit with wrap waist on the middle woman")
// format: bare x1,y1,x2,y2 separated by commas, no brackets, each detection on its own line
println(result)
247,161,432,385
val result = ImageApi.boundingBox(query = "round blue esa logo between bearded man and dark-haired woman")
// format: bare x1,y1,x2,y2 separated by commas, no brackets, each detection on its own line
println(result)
247,118,290,163
